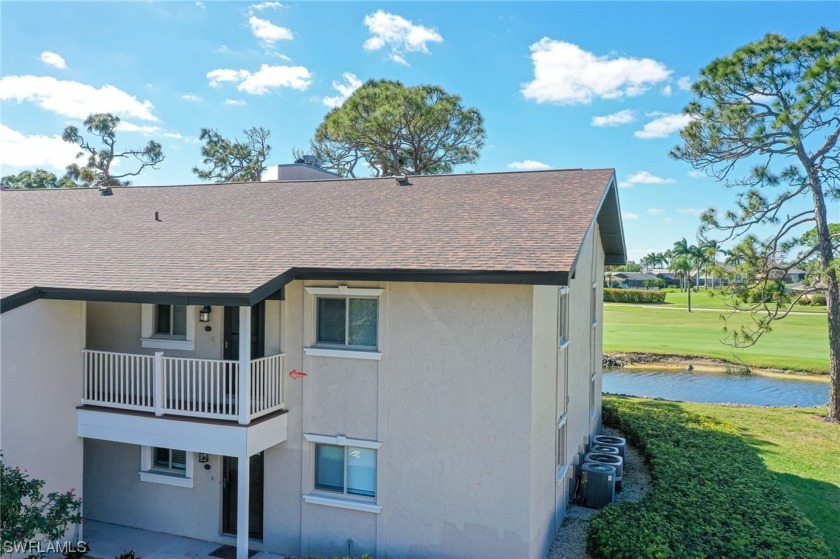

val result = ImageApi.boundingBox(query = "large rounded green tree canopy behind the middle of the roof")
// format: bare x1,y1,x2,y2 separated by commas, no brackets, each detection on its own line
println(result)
310,80,486,177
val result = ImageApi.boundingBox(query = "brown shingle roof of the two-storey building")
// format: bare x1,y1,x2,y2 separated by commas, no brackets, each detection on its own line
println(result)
0,169,624,310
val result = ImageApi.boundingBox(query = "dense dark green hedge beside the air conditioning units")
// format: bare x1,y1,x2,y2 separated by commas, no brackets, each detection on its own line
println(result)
587,397,829,559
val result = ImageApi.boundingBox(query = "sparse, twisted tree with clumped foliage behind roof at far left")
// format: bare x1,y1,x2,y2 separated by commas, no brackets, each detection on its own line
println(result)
61,113,164,186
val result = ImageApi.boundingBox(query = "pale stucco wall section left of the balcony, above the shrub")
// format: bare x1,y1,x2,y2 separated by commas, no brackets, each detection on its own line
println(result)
0,300,86,524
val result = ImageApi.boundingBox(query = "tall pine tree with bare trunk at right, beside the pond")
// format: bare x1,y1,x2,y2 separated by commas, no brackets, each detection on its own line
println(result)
671,29,840,420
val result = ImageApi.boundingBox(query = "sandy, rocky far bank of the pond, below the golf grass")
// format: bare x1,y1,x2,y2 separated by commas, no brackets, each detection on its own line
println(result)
603,352,830,383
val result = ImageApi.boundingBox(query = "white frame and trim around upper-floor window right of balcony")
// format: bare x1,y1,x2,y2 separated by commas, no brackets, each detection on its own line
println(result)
303,285,384,361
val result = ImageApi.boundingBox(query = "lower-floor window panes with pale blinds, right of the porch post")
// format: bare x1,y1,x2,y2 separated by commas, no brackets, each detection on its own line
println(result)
315,444,376,497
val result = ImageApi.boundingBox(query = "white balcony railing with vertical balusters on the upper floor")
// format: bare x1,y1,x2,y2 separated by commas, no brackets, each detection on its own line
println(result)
82,349,283,421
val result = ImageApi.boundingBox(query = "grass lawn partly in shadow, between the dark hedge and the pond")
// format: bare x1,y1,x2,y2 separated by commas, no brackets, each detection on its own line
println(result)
663,402,840,558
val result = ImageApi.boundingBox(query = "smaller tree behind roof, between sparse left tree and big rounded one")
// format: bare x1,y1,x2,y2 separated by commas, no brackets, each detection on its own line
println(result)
193,127,271,182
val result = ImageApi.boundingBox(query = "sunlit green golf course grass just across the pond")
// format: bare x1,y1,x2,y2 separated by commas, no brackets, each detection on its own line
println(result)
604,303,828,373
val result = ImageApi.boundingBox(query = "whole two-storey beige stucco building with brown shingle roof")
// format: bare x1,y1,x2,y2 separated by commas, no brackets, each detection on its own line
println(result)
0,167,628,559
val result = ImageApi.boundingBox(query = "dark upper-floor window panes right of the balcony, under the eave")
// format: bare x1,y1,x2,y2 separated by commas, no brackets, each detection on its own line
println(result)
315,297,379,349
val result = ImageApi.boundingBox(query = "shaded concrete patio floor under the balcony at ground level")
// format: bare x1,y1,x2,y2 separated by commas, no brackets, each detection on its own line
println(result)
84,520,284,559
